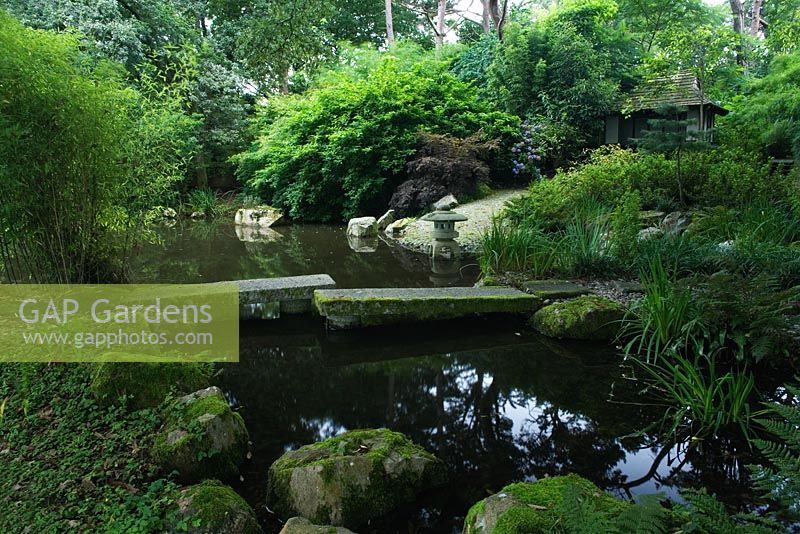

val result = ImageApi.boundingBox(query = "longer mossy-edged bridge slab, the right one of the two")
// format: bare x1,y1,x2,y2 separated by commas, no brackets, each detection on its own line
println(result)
314,287,541,329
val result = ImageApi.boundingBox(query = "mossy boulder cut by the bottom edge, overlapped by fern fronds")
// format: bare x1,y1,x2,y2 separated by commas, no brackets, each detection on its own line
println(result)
462,475,630,534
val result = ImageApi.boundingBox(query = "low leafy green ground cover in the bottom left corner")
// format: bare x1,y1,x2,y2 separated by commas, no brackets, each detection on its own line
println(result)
0,364,183,533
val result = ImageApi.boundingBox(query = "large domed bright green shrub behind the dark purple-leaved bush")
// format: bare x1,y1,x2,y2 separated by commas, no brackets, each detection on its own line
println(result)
236,44,519,221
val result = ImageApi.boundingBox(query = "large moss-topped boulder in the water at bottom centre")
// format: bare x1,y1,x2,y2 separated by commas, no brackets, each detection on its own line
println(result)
267,429,445,528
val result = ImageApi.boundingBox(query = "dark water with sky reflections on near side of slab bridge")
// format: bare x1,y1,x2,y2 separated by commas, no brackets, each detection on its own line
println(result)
216,319,752,532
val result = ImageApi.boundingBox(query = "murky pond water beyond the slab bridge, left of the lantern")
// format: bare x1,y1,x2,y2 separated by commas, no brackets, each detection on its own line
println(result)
131,221,479,288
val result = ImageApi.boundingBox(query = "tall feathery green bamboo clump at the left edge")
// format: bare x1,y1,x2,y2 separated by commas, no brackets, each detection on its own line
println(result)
0,13,196,282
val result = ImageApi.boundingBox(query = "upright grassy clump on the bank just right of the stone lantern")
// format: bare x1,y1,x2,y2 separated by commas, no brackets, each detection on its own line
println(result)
480,219,558,276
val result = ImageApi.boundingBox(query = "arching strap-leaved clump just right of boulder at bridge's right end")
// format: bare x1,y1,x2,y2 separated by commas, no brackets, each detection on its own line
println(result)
620,257,701,364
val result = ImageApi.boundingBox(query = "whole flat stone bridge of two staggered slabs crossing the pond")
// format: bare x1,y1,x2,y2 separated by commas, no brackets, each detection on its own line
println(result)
228,274,542,329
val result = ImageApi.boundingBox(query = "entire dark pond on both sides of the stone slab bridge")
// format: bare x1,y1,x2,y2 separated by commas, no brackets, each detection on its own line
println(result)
134,224,750,533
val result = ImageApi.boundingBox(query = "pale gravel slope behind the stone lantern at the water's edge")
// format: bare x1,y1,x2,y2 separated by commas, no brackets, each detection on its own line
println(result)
397,189,527,254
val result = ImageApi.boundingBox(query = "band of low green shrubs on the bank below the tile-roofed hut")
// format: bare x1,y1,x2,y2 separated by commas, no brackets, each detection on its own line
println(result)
508,146,797,234
